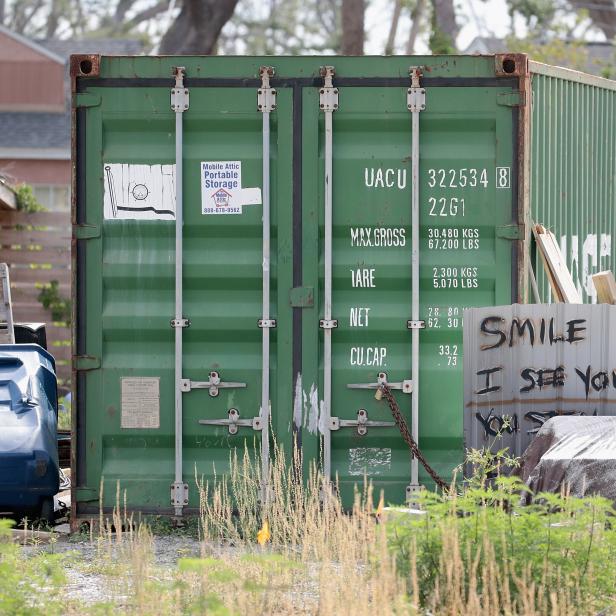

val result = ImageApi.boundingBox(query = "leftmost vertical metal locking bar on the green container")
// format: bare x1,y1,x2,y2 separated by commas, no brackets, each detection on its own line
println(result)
171,66,188,516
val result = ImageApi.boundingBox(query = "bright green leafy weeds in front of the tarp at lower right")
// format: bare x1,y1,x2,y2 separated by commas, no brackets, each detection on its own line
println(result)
387,438,616,614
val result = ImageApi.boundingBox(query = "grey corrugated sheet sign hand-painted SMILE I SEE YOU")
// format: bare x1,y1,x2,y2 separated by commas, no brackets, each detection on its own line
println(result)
464,304,616,455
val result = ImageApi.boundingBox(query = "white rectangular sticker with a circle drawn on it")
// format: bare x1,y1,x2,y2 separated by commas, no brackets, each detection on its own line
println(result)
103,163,175,220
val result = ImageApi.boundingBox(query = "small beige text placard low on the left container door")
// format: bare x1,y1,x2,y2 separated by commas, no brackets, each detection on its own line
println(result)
120,376,160,429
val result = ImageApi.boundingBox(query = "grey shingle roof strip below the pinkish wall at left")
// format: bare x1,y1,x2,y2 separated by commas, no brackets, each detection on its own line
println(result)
0,112,71,149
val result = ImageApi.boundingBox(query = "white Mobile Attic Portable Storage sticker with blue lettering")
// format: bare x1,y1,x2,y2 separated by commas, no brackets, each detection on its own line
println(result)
201,160,261,214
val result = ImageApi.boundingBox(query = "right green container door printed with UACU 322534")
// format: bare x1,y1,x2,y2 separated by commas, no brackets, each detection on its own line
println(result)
303,77,517,504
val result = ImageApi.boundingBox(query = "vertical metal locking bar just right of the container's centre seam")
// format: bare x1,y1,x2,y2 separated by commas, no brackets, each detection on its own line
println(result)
319,66,338,479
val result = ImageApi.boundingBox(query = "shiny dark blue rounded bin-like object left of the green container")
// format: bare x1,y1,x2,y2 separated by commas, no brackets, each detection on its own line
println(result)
0,344,59,522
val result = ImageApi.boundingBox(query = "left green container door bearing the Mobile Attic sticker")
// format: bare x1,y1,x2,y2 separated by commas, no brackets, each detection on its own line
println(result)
76,82,293,514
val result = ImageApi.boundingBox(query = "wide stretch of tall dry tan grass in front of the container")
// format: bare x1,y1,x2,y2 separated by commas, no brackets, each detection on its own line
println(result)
49,440,614,616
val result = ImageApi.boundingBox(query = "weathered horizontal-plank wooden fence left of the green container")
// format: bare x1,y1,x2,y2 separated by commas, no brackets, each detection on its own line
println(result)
0,211,71,389
